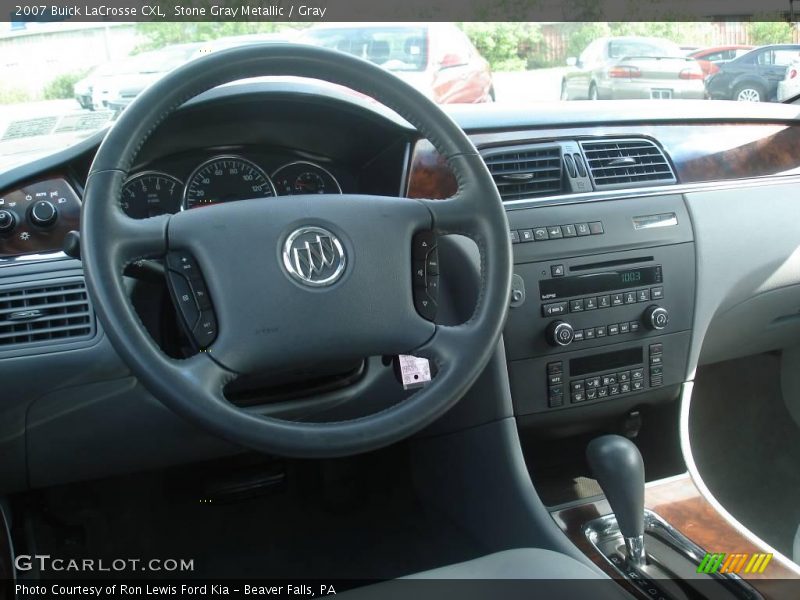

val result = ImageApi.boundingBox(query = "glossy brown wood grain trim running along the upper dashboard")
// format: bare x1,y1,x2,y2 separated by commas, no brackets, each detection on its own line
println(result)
408,123,800,198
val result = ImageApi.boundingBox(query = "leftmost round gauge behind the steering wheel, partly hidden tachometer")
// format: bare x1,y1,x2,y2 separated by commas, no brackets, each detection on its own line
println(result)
121,171,183,219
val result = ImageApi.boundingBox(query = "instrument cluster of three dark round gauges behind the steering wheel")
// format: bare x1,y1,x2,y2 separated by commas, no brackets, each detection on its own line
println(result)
121,154,342,219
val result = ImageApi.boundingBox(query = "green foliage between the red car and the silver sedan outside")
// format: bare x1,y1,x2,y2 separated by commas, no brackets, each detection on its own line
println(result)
460,23,542,71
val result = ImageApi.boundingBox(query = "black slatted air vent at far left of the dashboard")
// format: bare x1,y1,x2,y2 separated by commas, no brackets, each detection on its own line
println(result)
0,277,95,351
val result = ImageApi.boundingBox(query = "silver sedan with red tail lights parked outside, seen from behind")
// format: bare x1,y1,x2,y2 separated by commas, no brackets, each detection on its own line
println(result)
561,37,706,100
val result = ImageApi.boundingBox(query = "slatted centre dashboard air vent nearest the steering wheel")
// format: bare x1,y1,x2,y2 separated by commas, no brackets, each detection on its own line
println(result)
483,145,562,200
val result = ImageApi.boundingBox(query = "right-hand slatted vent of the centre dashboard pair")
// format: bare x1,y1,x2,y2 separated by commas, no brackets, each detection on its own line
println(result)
580,139,676,190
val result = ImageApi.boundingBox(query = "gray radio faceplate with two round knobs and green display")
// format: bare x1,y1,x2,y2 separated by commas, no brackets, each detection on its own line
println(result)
504,243,695,361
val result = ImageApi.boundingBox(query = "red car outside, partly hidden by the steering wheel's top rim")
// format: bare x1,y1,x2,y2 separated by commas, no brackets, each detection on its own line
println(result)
299,23,494,104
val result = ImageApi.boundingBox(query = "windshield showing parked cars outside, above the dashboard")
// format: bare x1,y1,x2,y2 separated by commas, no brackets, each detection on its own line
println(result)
0,21,800,168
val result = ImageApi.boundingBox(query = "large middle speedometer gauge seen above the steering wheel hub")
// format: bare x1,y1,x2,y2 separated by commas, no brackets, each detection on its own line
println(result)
183,156,275,209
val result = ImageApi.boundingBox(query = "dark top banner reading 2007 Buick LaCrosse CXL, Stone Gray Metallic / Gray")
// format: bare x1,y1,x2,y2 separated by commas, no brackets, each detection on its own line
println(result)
0,0,800,22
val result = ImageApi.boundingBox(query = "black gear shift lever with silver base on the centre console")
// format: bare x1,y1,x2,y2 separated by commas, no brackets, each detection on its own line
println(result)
586,435,646,566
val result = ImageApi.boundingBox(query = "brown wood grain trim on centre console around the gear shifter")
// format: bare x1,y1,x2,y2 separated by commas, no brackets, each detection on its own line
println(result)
552,474,800,598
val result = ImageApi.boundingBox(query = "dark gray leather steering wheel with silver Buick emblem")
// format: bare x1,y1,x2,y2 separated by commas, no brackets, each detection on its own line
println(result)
81,44,512,457
